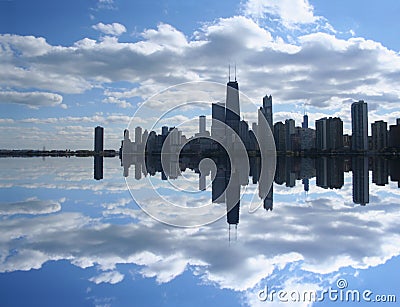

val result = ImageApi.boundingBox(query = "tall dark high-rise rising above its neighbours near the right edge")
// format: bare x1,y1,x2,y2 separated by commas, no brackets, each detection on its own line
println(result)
351,100,368,151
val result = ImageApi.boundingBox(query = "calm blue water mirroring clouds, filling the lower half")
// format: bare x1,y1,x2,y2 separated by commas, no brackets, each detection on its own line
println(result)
0,157,400,306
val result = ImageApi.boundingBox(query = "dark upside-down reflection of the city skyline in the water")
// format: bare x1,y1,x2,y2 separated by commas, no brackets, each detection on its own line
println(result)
118,154,400,228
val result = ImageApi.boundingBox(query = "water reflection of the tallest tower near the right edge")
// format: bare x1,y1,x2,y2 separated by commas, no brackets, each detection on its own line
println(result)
351,157,369,206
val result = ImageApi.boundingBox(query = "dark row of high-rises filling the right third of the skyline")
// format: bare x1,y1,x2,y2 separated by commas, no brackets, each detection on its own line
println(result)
274,100,400,153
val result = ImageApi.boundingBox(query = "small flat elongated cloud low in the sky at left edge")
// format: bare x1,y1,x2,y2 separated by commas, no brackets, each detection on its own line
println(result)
0,91,63,108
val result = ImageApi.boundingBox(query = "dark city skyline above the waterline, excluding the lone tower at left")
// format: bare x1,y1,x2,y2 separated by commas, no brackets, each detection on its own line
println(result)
121,80,400,158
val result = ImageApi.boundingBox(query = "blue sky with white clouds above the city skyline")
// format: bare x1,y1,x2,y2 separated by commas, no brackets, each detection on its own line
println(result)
0,0,400,149
